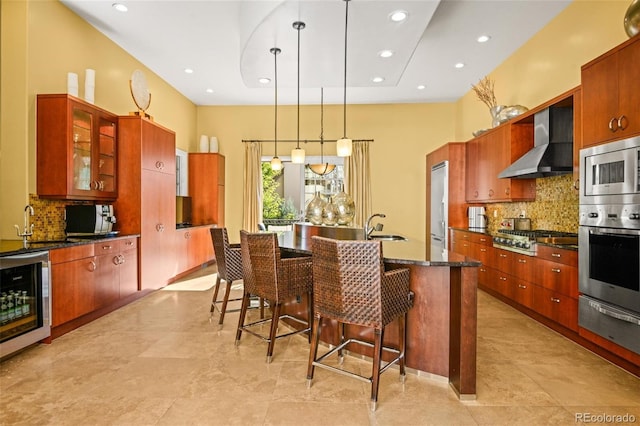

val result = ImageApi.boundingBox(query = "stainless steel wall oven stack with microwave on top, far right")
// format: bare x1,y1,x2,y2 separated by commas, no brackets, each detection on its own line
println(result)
578,137,640,354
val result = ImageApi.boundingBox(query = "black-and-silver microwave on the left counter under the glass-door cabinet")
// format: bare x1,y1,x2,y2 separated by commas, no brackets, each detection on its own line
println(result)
65,204,116,237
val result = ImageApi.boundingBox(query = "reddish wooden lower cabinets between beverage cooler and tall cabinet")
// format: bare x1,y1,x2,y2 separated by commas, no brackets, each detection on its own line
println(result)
49,237,138,327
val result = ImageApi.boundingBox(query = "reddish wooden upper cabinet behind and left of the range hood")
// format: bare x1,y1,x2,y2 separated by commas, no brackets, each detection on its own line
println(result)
465,123,536,203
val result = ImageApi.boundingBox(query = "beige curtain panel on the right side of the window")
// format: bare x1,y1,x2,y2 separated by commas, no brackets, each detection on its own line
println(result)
344,141,371,226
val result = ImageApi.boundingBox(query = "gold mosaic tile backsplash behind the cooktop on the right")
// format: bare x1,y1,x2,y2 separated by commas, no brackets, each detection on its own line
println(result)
486,175,579,233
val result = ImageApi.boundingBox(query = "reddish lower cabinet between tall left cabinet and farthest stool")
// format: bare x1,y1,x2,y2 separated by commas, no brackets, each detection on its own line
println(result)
175,226,214,275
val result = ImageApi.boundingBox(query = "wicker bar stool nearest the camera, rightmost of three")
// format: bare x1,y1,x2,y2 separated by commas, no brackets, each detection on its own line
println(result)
307,236,413,411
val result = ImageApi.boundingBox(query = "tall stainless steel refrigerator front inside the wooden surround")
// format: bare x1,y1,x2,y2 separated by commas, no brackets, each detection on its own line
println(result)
430,161,449,259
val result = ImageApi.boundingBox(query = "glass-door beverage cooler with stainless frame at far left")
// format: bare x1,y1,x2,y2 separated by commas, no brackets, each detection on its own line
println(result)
0,251,51,358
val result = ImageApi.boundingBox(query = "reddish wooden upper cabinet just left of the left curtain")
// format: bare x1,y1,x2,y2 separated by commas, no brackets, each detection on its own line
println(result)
189,153,225,227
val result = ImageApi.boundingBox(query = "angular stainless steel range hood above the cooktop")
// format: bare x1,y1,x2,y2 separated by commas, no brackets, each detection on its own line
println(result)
498,106,573,179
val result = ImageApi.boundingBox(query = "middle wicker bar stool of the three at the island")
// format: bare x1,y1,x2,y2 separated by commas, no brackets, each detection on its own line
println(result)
236,230,313,363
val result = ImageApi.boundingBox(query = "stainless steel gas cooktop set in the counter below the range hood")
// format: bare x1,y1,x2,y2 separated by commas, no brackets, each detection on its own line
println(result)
493,229,578,256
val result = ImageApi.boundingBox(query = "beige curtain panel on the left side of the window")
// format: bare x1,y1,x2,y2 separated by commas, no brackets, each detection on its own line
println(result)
242,142,262,232
